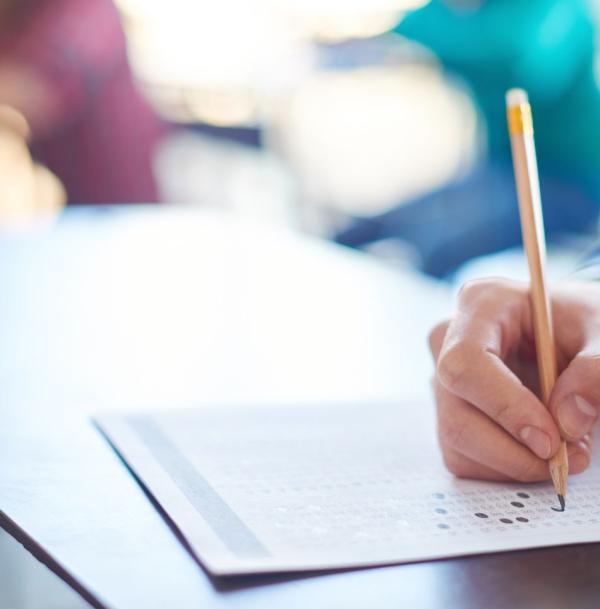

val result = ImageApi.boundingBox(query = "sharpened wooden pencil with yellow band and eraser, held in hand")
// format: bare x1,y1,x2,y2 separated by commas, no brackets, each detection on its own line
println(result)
506,89,569,511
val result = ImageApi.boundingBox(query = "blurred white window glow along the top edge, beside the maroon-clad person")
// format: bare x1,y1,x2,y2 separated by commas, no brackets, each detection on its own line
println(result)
116,0,427,125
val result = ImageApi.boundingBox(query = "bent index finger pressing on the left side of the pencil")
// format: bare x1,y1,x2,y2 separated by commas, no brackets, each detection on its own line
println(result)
437,282,560,459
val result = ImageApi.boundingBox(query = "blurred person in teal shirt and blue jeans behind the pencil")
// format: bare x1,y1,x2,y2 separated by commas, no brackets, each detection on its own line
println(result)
336,0,600,277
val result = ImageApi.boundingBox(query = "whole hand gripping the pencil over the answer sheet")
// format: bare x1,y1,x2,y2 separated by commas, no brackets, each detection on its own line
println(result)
429,280,600,482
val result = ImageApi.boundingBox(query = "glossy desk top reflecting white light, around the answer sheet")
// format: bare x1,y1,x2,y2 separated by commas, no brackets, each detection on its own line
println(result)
0,208,600,609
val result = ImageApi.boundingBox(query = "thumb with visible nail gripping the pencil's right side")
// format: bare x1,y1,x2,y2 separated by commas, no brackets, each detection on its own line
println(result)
549,347,600,441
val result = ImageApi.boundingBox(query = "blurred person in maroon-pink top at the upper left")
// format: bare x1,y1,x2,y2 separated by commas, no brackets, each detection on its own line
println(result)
0,0,165,203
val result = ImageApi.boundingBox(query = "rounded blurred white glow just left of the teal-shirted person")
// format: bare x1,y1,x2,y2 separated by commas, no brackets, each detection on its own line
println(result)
278,65,477,215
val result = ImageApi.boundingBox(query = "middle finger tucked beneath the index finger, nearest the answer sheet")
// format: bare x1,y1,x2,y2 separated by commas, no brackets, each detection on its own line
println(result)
435,382,549,482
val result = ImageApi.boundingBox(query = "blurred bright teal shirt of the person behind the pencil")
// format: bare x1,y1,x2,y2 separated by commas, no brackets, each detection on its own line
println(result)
396,0,600,195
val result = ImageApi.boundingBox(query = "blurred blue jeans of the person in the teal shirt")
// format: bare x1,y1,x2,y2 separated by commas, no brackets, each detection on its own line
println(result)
334,164,600,278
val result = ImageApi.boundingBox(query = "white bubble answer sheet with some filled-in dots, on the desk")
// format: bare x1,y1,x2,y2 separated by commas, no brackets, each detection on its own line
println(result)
97,403,600,576
